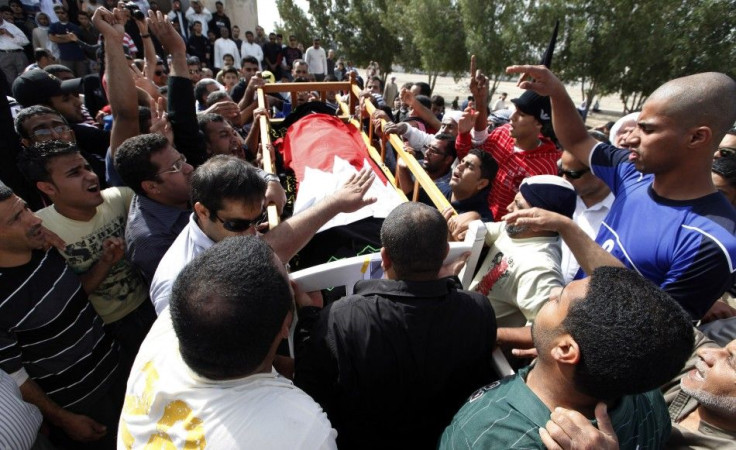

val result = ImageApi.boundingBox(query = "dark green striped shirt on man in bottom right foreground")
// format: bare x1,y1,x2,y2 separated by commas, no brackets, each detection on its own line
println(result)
439,367,672,450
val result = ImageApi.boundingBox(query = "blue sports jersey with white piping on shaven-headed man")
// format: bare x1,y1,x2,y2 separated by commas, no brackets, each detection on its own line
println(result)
590,143,736,320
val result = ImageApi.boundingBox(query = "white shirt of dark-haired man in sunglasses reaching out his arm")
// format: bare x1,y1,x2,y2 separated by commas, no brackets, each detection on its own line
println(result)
150,213,215,315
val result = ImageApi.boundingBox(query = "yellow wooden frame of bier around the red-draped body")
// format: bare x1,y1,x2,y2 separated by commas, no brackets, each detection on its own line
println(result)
254,73,455,228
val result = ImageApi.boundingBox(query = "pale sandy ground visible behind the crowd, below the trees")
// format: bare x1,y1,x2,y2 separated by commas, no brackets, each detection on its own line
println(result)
386,71,623,127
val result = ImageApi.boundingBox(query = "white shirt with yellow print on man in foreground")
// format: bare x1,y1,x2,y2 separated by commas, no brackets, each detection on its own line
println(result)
118,309,337,450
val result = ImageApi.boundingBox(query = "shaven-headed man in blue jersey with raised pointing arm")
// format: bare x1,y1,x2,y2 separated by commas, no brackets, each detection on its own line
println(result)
506,66,736,320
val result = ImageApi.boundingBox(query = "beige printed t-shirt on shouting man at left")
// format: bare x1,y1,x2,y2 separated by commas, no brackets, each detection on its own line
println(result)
36,187,148,323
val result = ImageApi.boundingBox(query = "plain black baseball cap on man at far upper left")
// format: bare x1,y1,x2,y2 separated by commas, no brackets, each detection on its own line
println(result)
13,69,82,107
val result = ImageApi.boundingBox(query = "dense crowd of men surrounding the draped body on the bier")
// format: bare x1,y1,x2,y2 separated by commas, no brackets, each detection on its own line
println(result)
0,0,736,449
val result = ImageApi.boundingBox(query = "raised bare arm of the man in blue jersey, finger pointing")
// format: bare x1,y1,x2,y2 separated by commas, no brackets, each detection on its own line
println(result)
506,66,598,164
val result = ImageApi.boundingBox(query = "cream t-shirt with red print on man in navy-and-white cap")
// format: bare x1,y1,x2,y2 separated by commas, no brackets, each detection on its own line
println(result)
470,222,562,327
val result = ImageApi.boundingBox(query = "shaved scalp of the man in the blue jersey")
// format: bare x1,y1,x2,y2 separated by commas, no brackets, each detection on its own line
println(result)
647,72,736,145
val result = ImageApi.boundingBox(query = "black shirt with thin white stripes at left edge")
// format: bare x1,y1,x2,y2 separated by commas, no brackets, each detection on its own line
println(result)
0,249,118,408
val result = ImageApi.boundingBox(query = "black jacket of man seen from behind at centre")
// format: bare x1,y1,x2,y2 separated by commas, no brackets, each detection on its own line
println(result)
294,278,497,449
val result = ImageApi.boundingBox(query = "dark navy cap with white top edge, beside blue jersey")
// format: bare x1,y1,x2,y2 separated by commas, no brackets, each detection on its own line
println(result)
519,175,577,218
